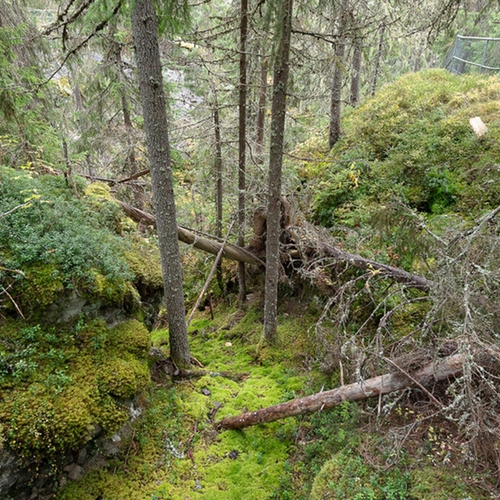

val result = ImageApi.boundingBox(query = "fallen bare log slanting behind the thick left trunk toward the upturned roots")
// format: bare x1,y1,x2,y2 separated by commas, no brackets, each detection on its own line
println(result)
116,200,265,266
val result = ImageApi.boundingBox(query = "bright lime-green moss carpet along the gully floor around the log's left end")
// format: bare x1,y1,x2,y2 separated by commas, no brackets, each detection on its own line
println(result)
60,310,308,500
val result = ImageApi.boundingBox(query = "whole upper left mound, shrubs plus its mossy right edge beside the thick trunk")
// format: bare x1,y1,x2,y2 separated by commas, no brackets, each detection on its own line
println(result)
0,167,162,321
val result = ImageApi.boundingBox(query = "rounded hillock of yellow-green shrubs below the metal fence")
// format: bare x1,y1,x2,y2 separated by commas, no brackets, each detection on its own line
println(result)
312,70,500,227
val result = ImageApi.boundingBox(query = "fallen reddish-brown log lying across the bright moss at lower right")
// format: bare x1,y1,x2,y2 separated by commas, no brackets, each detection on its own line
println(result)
217,354,464,429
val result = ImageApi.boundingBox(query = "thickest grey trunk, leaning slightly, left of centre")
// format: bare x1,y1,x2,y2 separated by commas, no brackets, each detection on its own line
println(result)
131,0,190,368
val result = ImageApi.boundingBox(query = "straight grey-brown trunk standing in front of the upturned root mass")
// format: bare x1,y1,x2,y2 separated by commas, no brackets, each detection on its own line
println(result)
264,0,293,342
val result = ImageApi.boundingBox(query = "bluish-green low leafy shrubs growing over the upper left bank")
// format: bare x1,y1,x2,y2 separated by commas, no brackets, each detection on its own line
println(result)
0,167,144,316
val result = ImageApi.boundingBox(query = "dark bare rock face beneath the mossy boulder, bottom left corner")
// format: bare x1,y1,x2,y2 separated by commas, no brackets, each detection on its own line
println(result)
0,401,142,500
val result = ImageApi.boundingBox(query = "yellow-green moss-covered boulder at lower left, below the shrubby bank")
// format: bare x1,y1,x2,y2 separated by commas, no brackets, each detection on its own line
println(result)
0,321,150,459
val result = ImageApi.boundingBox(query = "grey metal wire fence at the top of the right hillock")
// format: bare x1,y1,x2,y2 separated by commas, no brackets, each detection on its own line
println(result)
443,35,500,75
